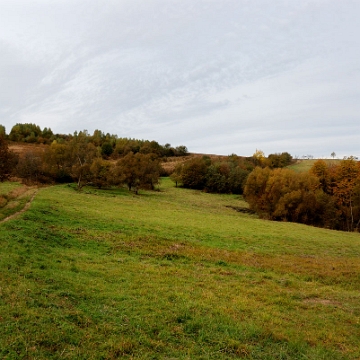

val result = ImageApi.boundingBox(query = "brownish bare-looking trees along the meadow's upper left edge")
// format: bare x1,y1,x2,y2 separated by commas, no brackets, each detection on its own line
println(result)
0,132,163,192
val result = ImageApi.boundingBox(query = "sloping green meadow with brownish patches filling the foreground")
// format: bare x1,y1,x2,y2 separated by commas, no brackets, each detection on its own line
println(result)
0,179,360,359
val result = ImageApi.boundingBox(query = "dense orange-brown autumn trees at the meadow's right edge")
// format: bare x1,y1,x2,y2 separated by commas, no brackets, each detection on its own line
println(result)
244,157,360,231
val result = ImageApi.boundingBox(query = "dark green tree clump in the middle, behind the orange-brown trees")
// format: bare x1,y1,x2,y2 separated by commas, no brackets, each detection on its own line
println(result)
170,150,292,194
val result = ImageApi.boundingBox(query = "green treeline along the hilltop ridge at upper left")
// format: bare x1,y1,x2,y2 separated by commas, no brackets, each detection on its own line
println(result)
0,123,188,159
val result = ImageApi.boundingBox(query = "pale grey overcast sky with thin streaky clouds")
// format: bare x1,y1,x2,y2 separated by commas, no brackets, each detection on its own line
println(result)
0,0,360,158
